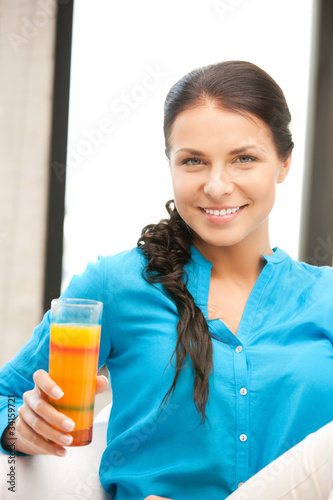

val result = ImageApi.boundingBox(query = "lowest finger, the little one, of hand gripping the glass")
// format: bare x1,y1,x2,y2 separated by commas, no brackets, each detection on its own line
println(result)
16,417,66,456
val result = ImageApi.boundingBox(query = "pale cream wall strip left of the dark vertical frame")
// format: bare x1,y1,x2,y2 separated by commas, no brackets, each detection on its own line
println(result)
0,0,57,366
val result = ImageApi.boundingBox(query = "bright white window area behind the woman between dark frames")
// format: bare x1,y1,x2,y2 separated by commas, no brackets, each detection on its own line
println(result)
62,0,315,289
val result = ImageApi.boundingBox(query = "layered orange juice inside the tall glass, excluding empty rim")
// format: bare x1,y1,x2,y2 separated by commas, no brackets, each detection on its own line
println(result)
49,323,101,446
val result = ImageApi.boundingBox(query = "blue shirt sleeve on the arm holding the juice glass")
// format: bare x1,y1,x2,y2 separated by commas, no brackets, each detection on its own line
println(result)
0,257,111,454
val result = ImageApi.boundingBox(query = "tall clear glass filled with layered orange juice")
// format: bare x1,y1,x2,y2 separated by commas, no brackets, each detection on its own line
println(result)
48,299,103,446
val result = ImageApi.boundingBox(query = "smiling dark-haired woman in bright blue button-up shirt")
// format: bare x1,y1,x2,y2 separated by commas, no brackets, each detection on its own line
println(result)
1,61,333,500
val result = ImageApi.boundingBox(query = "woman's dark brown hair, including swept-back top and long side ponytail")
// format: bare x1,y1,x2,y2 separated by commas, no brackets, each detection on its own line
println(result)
138,61,294,423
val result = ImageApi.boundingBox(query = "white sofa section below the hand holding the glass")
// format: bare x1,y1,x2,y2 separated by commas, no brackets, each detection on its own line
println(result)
0,404,112,500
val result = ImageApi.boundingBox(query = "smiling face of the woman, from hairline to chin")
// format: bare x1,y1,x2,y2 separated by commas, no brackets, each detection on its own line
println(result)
169,104,291,254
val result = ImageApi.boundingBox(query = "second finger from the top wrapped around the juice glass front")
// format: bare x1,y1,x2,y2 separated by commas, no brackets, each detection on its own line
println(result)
20,389,75,432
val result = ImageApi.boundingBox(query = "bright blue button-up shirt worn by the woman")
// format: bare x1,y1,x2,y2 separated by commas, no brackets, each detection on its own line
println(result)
0,246,333,500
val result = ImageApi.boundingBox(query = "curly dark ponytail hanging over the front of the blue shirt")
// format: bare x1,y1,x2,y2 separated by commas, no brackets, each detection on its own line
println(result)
137,200,213,424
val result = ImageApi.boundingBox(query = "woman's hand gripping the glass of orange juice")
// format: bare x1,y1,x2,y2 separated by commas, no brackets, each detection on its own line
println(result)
2,370,108,457
